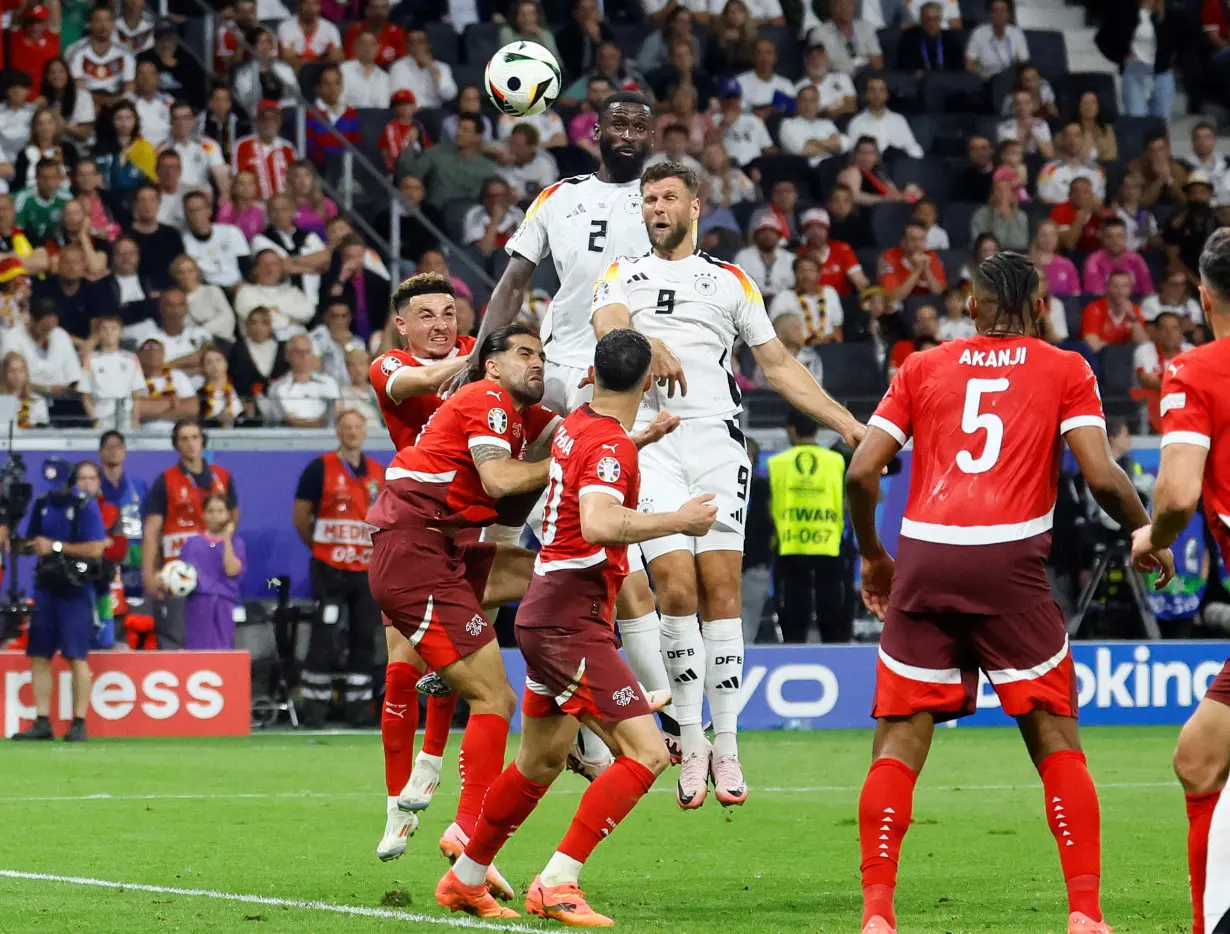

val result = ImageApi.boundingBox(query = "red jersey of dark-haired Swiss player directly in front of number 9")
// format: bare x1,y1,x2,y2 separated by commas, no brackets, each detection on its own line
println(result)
530,402,641,621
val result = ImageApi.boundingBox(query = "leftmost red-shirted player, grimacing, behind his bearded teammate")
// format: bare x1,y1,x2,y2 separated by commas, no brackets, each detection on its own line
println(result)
370,272,475,860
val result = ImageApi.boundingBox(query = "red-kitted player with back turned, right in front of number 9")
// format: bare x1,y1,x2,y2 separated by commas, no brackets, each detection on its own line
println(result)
435,330,717,927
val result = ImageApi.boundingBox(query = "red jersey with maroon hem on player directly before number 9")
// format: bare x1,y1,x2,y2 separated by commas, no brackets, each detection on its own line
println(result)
517,402,641,628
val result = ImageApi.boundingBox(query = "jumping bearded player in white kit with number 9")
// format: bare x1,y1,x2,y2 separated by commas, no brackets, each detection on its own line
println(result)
593,162,865,808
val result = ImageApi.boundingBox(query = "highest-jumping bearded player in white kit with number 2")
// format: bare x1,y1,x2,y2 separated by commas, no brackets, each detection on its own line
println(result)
445,91,679,780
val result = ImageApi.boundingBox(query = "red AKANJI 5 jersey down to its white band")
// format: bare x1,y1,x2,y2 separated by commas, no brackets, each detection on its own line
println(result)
868,336,1106,545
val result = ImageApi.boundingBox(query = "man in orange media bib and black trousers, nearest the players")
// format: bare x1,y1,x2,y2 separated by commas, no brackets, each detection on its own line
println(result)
293,410,383,728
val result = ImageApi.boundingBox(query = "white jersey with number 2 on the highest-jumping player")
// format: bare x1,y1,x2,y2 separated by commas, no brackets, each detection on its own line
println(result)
504,175,649,369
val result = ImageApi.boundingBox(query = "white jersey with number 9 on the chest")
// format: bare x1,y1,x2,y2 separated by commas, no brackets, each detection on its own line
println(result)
593,252,777,422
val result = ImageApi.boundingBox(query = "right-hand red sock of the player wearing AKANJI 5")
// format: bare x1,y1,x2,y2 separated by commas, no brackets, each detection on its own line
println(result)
1038,749,1102,920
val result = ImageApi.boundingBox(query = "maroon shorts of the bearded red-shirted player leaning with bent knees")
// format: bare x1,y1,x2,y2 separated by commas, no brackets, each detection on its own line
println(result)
368,529,496,671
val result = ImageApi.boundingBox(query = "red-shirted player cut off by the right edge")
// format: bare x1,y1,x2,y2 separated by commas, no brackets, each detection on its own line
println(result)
1132,228,1230,934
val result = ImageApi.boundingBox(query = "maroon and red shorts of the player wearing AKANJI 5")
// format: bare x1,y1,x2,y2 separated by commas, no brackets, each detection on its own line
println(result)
871,601,1079,721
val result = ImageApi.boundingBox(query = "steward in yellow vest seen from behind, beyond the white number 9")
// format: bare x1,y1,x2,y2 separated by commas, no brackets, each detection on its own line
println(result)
769,410,854,642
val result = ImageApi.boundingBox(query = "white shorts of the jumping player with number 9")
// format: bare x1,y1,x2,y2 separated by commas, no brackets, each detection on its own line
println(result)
640,418,752,564
